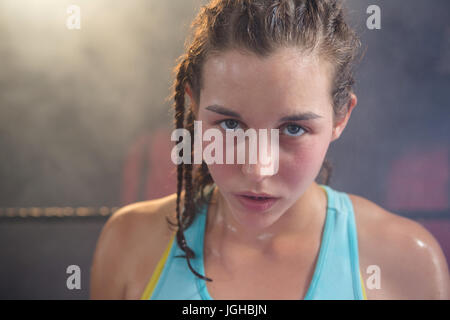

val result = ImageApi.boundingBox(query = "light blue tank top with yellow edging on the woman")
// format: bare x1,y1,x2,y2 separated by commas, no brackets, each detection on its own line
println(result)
141,184,366,300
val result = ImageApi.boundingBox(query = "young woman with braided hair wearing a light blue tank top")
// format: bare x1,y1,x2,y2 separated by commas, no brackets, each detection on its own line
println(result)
91,0,449,299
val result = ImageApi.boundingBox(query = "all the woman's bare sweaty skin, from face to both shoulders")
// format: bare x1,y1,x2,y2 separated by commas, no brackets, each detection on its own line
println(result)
91,49,450,300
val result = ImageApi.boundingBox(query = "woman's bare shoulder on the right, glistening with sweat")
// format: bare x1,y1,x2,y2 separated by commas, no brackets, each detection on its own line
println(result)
348,194,450,299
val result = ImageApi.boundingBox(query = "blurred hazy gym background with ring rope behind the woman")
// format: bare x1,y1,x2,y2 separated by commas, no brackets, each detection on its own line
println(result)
0,0,450,299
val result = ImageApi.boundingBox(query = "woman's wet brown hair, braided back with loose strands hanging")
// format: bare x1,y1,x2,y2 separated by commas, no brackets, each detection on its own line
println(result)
167,0,360,281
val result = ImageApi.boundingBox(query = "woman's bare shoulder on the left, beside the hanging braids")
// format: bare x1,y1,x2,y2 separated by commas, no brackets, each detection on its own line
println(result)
90,190,183,299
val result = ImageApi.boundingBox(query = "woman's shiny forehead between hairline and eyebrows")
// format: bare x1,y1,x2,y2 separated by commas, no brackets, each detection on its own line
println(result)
200,48,331,110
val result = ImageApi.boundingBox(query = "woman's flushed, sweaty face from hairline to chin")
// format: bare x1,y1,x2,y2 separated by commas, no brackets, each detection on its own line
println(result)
188,49,350,229
